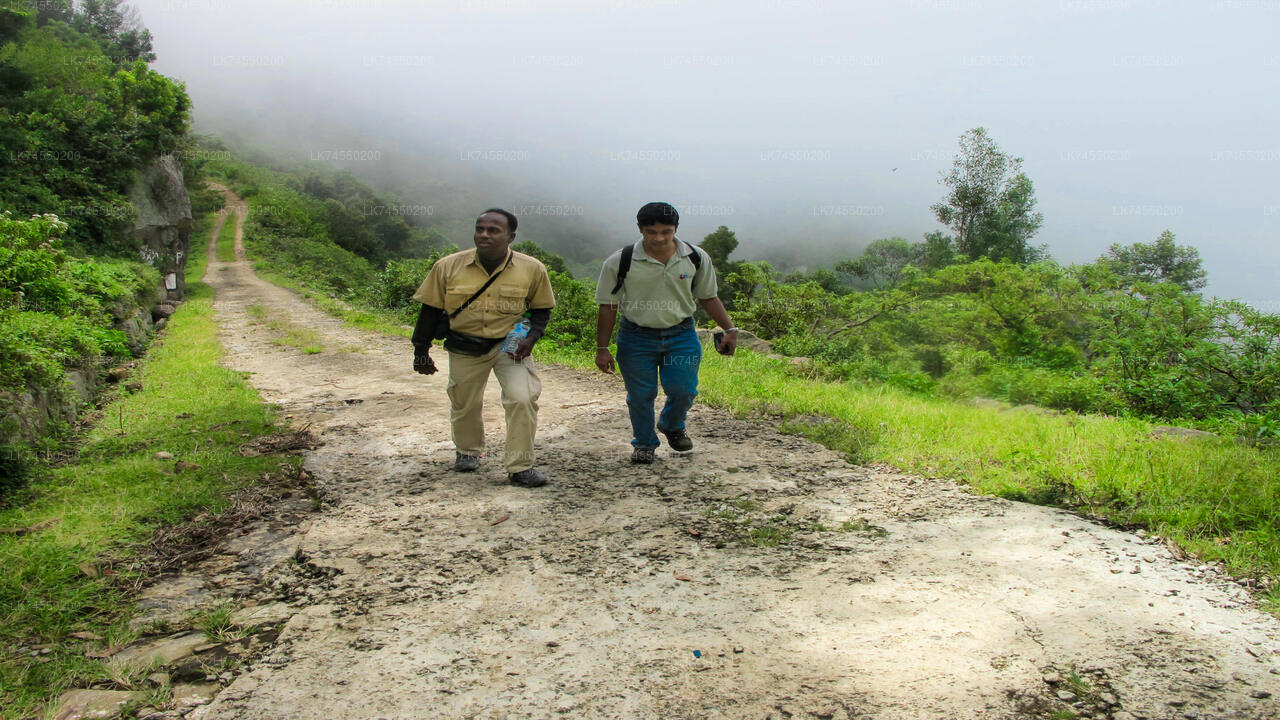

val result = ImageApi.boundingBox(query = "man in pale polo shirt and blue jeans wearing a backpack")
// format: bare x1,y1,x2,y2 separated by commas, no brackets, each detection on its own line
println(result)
595,202,737,464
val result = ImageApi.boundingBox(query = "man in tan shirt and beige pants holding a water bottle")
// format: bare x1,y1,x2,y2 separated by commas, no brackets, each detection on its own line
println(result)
413,209,556,487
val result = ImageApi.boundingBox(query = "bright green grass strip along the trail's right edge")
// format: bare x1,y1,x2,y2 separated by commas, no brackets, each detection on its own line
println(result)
535,345,1280,611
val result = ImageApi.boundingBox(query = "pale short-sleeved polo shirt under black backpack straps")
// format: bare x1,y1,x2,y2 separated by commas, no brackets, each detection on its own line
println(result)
595,240,718,328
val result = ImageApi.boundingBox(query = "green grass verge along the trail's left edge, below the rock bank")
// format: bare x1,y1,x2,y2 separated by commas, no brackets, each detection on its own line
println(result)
0,215,293,717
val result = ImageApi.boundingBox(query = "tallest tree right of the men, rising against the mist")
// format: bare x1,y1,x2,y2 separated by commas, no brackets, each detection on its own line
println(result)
931,127,1044,264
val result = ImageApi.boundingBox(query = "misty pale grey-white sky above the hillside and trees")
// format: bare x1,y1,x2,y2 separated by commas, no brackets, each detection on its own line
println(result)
133,0,1280,304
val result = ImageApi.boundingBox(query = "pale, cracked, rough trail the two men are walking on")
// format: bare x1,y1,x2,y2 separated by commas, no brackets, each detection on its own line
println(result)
192,185,1280,720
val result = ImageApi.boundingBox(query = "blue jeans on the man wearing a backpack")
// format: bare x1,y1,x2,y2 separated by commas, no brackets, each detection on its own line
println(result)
618,318,703,447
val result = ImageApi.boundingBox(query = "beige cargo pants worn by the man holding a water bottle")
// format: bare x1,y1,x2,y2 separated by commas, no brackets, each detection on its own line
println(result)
448,345,543,473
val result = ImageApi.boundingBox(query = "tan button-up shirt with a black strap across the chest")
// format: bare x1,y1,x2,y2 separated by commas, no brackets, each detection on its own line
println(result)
413,250,556,338
